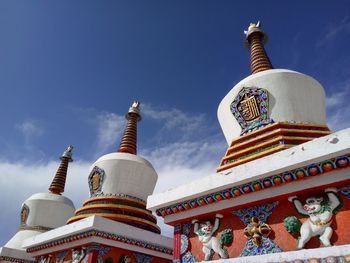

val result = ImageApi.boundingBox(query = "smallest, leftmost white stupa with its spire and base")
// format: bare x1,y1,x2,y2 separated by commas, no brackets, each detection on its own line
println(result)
0,145,75,262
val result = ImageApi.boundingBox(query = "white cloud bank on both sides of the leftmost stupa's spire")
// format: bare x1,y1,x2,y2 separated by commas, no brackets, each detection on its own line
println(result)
0,160,91,246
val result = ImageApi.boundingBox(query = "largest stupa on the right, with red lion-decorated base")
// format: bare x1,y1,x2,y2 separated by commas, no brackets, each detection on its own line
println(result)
147,23,350,263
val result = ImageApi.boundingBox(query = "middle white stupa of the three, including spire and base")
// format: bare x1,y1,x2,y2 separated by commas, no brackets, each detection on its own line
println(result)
24,101,172,263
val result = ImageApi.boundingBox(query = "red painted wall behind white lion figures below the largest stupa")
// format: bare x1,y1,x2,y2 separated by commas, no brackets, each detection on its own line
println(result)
181,190,350,260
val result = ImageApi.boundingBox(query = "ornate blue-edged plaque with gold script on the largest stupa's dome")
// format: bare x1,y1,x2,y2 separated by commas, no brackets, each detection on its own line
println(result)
230,87,273,134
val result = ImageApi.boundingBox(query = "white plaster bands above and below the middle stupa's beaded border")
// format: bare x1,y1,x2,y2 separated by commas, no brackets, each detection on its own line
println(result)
24,216,173,258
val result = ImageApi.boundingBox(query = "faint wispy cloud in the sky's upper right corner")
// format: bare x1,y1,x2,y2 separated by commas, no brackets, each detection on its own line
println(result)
317,17,350,47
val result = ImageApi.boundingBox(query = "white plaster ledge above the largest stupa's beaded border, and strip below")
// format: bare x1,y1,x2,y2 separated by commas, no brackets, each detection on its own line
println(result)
147,129,350,219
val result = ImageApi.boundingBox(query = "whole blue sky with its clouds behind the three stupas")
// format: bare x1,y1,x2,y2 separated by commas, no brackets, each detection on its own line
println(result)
0,0,350,245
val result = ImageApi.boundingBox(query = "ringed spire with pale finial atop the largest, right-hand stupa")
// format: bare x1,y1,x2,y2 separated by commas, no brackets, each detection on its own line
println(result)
244,22,273,74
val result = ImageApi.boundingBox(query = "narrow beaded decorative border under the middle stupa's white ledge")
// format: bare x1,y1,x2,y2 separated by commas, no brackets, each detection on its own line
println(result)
27,230,173,255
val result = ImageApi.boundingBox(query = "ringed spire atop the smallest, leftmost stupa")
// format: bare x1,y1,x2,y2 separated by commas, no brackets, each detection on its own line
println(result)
49,145,73,195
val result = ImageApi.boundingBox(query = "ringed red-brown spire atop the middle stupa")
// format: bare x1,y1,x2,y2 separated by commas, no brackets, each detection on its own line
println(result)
118,101,141,154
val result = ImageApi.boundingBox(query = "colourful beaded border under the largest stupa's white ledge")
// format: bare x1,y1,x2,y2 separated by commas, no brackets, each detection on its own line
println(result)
156,154,350,217
